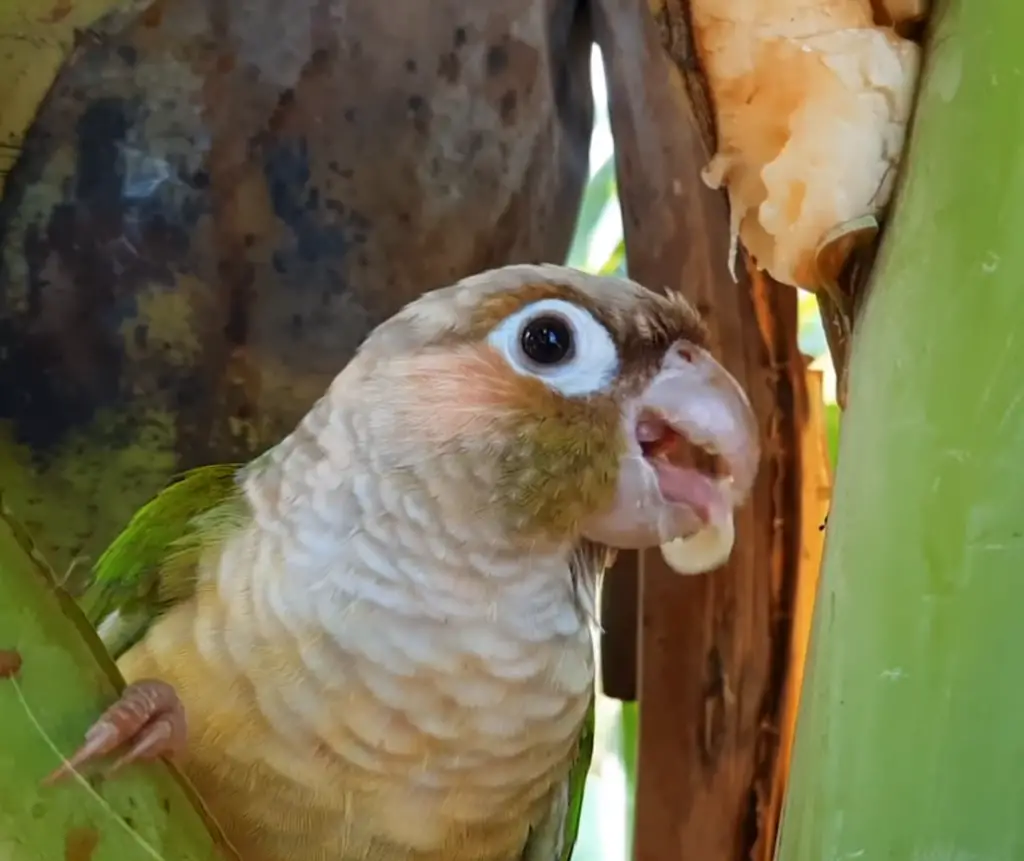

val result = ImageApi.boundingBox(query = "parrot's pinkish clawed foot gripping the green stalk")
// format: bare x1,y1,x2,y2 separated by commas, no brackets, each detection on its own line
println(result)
43,679,187,784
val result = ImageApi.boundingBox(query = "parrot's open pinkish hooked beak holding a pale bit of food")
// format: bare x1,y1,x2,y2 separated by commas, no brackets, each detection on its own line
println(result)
587,342,760,573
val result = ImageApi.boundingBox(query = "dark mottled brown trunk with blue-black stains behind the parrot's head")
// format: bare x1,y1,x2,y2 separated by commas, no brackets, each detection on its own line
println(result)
0,0,593,567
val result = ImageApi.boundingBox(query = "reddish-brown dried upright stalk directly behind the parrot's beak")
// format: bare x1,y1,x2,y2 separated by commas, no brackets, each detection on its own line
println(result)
594,0,813,861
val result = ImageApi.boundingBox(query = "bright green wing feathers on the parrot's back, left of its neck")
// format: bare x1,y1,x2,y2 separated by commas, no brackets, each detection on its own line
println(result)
79,464,246,657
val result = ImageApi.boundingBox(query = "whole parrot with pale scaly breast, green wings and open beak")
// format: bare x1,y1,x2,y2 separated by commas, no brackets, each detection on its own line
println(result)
46,264,760,861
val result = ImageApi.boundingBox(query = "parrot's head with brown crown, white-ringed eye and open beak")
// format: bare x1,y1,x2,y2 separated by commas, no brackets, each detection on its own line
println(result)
319,265,759,572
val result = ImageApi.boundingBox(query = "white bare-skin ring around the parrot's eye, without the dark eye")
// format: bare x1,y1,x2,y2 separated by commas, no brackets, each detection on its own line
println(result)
487,299,618,397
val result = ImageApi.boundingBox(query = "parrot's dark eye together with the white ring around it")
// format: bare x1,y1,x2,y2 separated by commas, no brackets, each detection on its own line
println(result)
487,299,618,397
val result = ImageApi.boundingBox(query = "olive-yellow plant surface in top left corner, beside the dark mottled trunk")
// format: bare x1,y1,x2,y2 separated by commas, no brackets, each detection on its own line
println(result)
0,0,144,197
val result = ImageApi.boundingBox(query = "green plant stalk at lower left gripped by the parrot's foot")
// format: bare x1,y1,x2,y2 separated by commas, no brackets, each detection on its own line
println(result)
0,500,234,861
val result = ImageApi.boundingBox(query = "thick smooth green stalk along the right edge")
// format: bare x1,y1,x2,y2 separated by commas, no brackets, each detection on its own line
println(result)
776,0,1024,861
